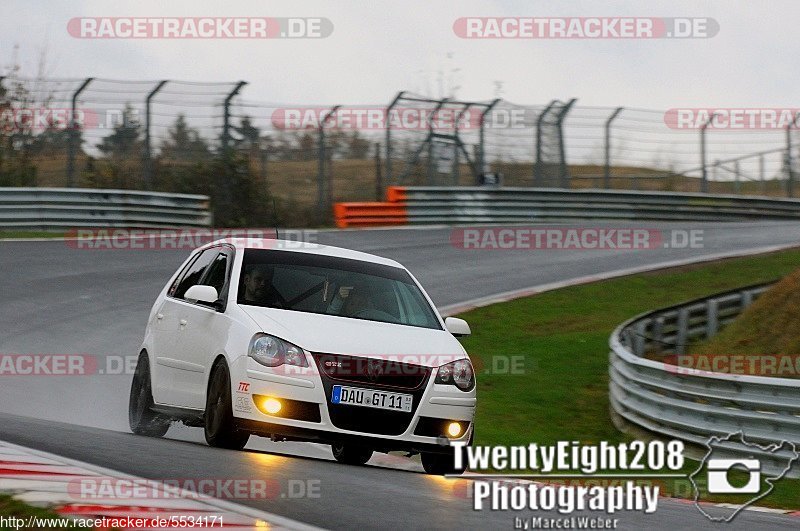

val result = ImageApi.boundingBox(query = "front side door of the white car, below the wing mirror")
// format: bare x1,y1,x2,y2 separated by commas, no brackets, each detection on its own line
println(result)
176,246,233,409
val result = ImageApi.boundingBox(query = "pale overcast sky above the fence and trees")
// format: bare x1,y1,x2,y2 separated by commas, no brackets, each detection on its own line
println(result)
0,0,800,109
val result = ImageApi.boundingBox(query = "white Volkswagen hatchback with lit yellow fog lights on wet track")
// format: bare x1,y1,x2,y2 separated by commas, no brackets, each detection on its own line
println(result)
129,239,476,474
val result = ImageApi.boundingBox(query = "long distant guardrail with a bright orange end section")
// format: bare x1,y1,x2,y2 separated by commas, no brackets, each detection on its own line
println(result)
334,186,800,227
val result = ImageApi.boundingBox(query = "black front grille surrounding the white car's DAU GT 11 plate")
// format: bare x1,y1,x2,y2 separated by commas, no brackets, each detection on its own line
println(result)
313,353,431,435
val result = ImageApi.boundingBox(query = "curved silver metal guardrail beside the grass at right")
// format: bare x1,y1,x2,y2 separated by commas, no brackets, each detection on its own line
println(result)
609,284,800,475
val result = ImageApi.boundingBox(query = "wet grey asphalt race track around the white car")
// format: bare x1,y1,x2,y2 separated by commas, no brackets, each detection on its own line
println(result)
0,222,800,529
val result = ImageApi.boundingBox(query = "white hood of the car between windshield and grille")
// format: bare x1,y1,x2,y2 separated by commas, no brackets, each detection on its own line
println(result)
241,306,466,367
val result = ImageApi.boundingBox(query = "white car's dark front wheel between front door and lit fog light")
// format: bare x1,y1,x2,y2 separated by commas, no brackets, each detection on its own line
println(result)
203,361,250,450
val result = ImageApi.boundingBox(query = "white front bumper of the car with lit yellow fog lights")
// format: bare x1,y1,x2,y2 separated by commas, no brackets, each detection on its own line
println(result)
231,357,476,453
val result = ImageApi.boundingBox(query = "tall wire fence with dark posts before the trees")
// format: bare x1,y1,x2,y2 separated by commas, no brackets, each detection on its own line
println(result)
0,75,800,223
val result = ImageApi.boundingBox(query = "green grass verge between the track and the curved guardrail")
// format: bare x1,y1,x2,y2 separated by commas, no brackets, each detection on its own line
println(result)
459,250,800,509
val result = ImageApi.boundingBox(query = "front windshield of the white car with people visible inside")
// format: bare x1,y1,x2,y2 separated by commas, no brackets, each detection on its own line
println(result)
237,249,441,330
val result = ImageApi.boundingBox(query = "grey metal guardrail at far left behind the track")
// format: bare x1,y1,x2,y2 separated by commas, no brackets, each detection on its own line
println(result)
0,188,212,230
